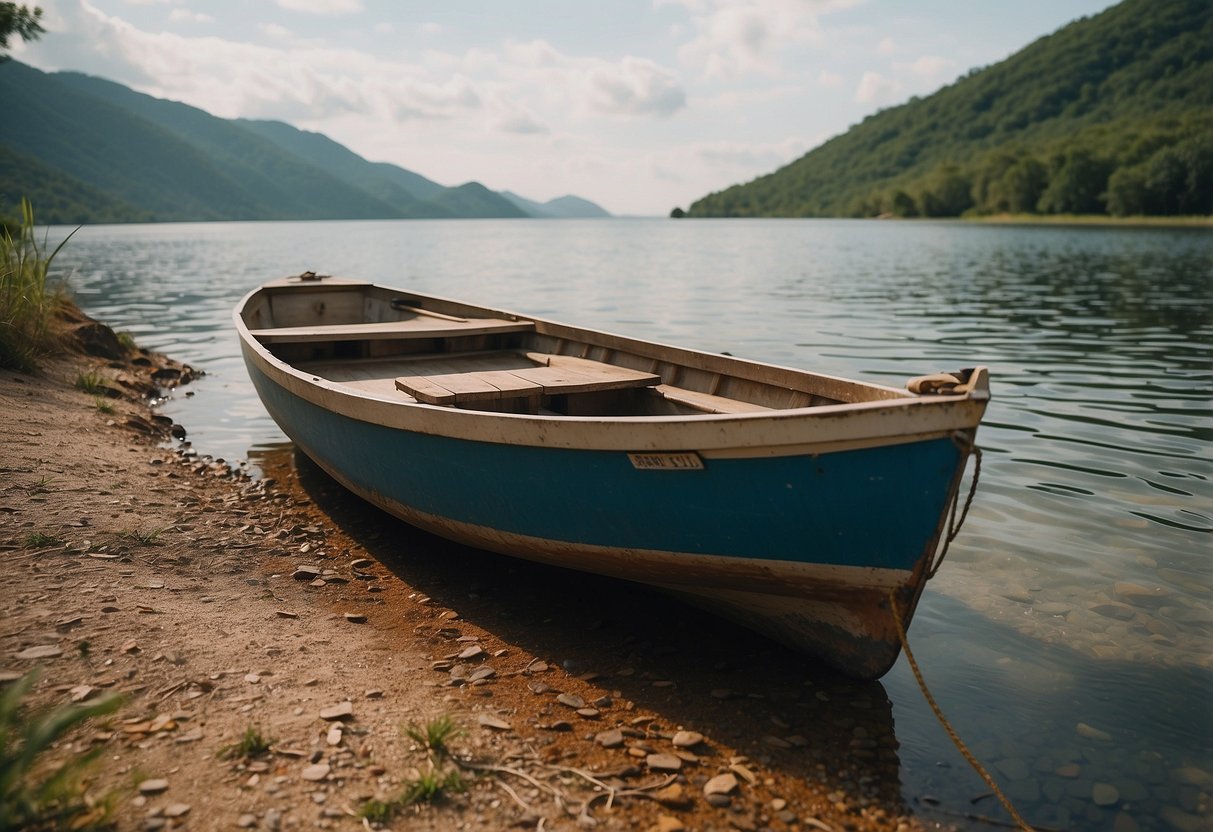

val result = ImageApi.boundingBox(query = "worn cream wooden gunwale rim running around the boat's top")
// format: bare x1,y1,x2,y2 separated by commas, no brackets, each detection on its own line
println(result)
233,278,990,456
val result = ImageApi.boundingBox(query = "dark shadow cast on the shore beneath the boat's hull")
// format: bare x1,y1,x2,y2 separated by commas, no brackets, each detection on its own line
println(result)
277,451,909,815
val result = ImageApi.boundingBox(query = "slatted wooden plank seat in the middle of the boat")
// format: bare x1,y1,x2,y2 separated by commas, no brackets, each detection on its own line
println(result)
395,353,661,405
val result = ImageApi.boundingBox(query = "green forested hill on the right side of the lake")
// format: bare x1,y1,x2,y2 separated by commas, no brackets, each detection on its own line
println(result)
673,0,1213,217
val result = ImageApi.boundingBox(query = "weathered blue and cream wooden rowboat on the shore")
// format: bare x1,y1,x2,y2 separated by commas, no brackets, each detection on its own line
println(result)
234,272,990,679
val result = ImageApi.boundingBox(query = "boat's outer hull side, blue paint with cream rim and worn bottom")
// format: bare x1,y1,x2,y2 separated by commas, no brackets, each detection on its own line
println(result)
237,278,989,678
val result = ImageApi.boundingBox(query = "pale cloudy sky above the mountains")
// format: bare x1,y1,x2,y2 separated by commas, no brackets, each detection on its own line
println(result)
12,0,1114,216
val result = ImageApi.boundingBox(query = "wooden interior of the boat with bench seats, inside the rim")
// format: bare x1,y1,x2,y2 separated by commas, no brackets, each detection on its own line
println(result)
243,281,910,416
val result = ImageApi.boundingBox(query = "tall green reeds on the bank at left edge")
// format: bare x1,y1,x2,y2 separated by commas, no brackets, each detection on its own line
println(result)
0,199,75,372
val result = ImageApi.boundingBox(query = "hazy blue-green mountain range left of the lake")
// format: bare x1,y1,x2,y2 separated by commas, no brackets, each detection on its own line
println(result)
0,61,605,223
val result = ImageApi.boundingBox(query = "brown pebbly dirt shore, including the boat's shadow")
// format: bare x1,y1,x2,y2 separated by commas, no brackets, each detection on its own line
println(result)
0,315,965,832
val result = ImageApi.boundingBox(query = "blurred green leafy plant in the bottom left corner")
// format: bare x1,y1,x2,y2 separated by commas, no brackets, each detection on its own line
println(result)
0,673,123,832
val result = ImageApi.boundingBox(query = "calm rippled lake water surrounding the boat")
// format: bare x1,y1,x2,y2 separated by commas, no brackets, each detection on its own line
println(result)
52,220,1213,830
